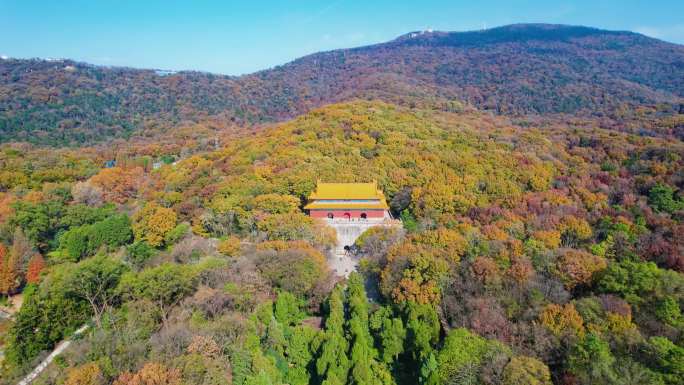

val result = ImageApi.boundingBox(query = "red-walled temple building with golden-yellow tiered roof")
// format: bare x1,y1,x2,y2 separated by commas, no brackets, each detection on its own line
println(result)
304,181,391,221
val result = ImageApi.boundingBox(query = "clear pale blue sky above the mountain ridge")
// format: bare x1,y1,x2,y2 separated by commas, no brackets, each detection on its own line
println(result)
0,0,684,75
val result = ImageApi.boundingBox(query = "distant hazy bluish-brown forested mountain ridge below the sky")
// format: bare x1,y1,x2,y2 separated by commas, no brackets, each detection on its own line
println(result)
0,24,684,145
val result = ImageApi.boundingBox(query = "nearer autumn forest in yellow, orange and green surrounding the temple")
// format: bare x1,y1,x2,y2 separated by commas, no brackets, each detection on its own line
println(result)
0,102,684,385
